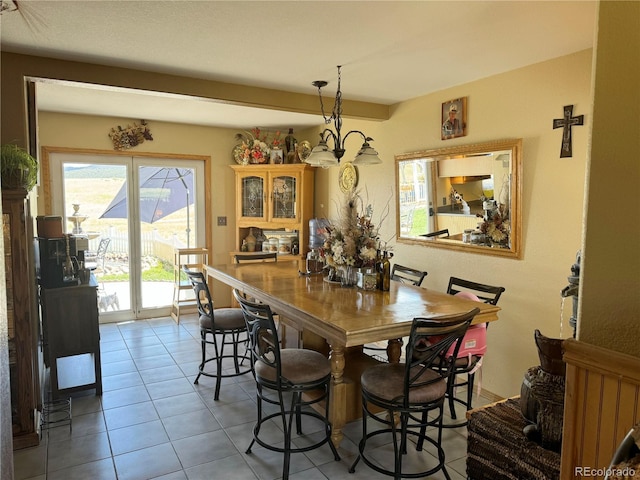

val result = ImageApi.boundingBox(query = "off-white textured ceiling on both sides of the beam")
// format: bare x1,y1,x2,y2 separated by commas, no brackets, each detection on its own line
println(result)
0,0,597,127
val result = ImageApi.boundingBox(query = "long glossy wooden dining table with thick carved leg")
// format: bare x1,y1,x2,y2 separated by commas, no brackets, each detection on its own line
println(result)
206,262,500,446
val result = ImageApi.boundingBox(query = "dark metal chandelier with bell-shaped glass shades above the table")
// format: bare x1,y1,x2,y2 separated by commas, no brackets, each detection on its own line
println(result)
305,65,382,168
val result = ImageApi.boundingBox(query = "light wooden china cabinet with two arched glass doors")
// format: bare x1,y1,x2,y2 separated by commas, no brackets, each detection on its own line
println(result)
231,163,315,260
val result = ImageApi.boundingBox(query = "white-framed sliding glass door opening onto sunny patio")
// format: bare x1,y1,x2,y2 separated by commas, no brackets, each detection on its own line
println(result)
50,153,205,322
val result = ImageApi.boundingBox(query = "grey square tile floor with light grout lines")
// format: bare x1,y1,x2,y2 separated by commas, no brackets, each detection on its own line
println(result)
14,316,496,480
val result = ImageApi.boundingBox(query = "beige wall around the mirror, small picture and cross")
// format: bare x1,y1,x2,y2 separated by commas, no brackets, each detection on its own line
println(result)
316,50,592,397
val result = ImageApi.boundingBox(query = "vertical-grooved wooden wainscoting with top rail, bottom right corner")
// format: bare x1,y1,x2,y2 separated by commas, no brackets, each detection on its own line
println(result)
560,339,640,478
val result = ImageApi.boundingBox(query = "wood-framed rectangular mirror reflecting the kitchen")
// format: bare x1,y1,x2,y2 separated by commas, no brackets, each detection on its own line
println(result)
395,139,522,258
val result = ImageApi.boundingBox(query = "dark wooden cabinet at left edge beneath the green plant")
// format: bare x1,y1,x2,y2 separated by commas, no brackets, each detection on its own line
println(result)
2,189,42,449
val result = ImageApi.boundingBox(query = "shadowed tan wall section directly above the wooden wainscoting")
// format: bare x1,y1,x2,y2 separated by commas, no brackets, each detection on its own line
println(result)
579,2,640,357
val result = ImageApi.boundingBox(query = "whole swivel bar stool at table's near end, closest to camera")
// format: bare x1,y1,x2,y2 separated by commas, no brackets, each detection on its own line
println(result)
349,308,480,480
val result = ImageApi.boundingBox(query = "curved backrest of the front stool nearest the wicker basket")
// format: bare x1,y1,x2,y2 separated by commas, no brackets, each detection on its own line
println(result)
402,308,480,406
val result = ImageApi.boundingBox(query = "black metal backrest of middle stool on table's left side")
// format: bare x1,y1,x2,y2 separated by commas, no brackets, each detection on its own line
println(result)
233,289,286,389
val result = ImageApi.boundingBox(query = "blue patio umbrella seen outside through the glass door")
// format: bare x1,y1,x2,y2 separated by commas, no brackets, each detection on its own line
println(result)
100,167,193,248
